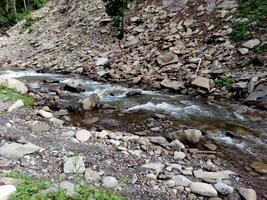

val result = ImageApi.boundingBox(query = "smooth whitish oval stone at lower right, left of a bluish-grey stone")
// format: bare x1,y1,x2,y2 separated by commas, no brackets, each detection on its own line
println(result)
190,182,218,197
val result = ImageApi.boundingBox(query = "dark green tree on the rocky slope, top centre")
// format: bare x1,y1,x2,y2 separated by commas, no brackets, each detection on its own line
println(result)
102,0,132,39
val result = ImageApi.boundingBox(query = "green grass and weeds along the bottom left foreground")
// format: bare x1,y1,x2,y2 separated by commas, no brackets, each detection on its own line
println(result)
1,172,124,200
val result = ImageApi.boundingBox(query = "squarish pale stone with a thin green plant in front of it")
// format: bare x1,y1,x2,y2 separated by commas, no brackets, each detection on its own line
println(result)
63,156,85,174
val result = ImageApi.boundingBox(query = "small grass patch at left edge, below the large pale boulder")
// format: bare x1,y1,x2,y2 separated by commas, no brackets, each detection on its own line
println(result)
0,86,34,106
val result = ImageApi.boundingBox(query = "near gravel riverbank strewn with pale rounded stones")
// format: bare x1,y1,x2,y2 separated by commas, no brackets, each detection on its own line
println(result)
0,75,266,200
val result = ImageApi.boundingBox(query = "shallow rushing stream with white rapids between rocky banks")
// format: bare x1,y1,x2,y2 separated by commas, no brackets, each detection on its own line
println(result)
0,71,267,178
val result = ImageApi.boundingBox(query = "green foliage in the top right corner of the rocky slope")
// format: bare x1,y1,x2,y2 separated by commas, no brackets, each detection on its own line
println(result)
231,0,267,42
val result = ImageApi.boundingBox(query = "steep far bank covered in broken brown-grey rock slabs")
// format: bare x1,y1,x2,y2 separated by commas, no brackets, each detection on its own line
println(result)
0,0,266,108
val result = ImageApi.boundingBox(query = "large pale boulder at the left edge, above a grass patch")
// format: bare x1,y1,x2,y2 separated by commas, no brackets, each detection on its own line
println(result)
0,75,28,94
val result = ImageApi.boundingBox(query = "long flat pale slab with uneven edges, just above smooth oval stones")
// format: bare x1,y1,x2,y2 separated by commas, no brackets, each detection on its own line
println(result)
194,169,235,181
